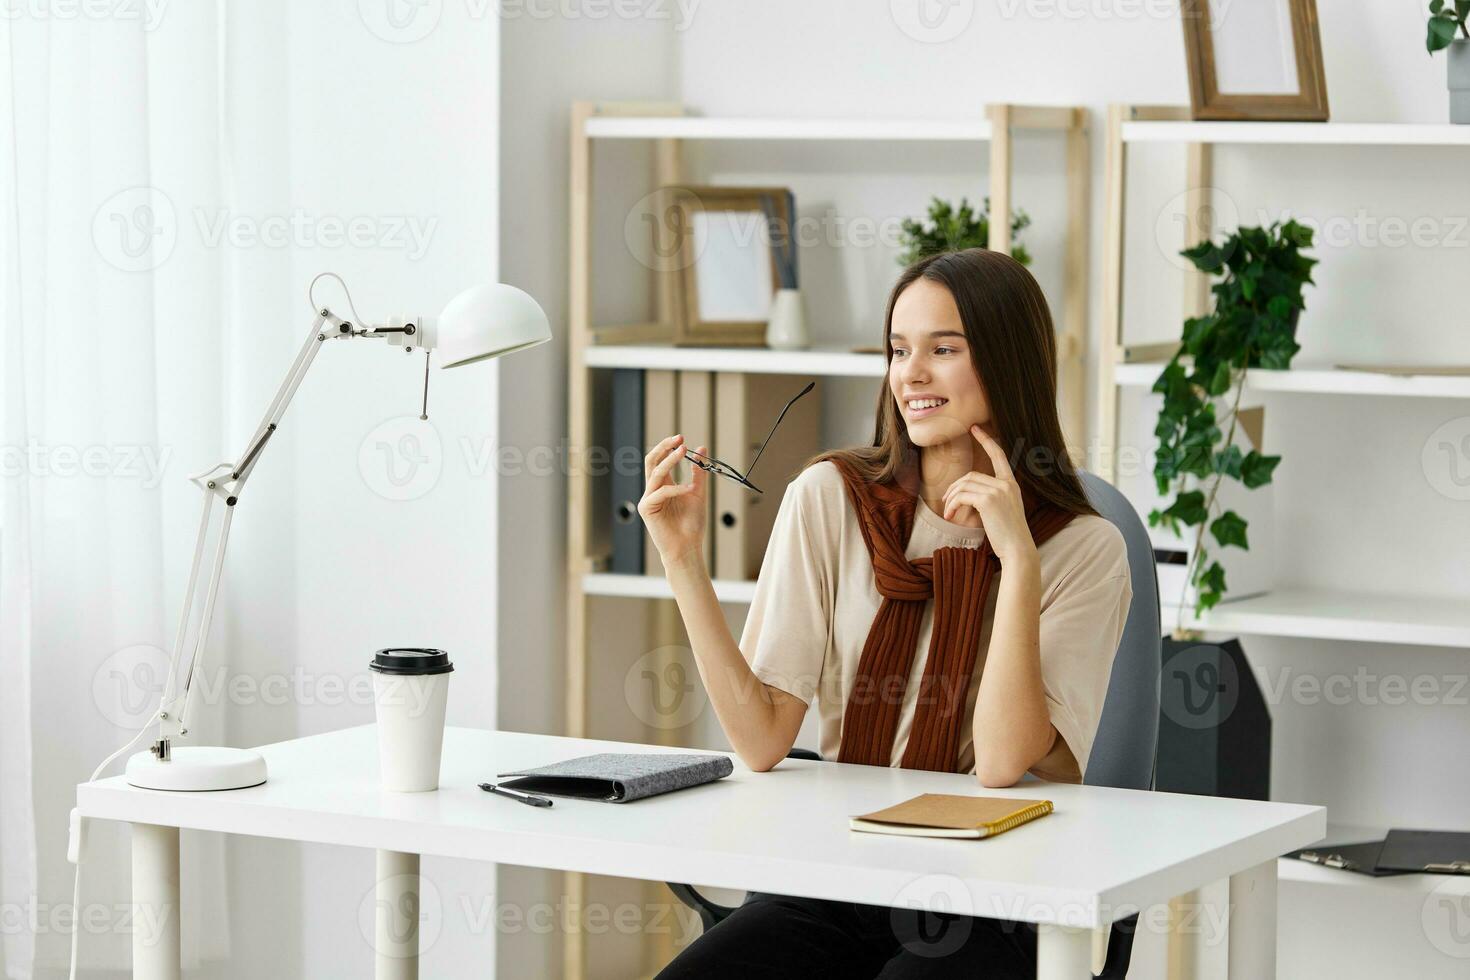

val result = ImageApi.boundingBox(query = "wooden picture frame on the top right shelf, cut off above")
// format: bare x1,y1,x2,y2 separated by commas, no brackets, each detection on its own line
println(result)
1180,0,1327,122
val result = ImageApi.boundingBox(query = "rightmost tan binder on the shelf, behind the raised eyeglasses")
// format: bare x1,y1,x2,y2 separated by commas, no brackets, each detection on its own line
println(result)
710,372,822,580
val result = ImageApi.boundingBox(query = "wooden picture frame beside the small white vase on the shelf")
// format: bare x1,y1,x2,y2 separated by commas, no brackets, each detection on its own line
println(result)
673,187,794,347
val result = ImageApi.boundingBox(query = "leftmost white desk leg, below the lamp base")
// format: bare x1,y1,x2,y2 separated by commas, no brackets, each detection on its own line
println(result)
131,823,184,980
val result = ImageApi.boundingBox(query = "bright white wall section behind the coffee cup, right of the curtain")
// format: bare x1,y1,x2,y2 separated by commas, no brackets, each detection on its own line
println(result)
269,3,503,976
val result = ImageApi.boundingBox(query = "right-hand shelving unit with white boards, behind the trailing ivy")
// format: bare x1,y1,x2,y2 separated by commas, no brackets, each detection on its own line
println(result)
1097,106,1470,928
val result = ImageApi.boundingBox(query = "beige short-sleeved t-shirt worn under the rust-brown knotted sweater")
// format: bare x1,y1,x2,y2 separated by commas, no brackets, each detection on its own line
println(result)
739,461,1133,782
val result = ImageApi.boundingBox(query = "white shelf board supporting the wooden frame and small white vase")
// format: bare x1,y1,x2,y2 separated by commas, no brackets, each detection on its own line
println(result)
585,344,886,378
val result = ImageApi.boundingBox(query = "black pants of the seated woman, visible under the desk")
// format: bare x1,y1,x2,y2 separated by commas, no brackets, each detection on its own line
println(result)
656,892,1036,980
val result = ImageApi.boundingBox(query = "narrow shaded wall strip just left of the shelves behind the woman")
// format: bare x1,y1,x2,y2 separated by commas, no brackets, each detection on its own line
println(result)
495,3,676,977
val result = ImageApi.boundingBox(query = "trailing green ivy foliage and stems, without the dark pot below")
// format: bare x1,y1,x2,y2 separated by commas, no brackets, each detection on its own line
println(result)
1148,218,1323,619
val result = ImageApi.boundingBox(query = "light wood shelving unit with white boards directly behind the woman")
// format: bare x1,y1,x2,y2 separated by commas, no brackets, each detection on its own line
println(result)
563,101,1091,980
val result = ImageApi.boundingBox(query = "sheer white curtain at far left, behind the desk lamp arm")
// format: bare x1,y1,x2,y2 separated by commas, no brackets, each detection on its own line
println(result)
0,3,254,977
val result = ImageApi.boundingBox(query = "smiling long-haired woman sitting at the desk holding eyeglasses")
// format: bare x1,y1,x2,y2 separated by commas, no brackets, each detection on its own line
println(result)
638,248,1132,980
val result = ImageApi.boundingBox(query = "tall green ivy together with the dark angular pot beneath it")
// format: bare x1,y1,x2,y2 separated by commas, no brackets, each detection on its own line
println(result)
1148,221,1317,799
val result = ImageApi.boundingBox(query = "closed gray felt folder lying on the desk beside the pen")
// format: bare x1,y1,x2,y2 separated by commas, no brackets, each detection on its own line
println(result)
497,752,735,804
